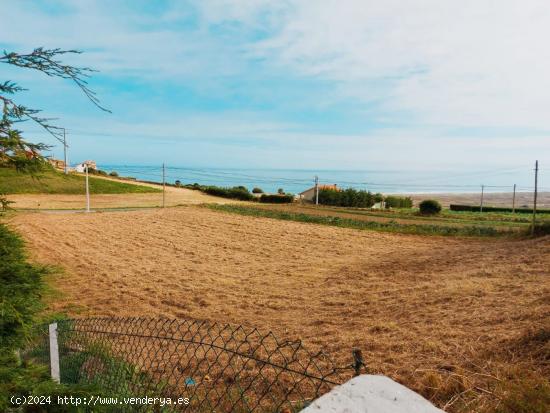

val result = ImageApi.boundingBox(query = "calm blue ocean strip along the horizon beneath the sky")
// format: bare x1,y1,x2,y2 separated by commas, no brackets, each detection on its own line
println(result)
98,164,550,194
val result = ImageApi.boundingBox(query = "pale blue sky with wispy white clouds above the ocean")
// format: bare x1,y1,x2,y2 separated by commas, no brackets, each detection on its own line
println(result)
0,0,550,175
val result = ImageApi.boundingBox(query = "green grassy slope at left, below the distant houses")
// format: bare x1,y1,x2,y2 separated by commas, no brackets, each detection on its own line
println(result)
0,168,160,195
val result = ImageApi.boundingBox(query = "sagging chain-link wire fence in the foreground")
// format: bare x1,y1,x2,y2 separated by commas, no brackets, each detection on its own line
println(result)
25,318,362,413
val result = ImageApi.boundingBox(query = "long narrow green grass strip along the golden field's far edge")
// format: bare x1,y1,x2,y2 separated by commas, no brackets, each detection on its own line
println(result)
204,204,518,237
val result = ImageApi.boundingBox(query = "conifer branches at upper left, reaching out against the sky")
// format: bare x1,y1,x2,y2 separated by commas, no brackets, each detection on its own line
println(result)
0,48,109,171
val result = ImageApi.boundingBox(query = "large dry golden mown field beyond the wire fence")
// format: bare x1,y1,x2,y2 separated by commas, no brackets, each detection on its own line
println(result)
10,206,550,412
